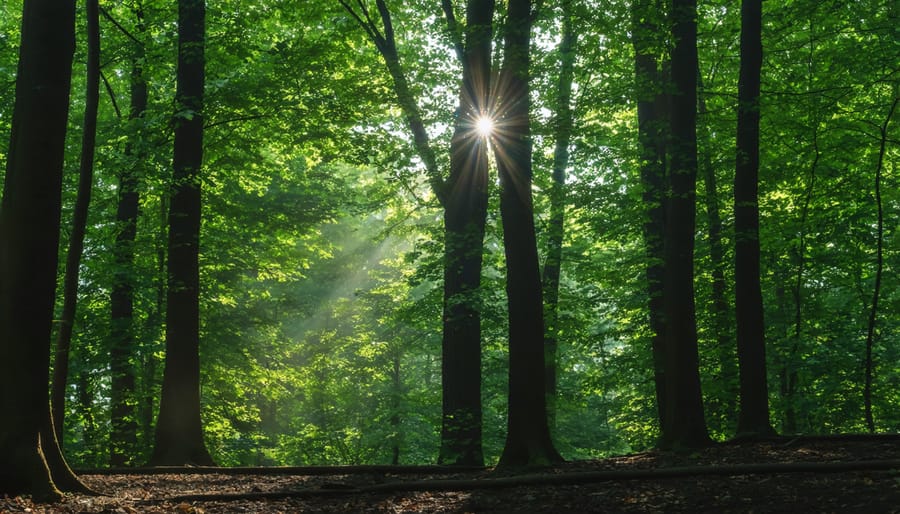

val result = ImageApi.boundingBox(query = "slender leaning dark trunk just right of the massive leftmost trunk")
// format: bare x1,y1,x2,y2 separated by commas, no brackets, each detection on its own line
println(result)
50,0,100,447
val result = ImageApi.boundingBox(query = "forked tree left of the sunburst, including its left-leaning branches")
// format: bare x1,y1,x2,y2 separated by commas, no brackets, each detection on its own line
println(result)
341,0,494,465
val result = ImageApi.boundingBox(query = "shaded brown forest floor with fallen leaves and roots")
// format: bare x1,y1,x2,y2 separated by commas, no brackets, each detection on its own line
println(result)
0,435,900,514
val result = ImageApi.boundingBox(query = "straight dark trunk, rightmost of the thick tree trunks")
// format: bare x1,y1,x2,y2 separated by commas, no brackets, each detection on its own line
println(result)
734,0,775,436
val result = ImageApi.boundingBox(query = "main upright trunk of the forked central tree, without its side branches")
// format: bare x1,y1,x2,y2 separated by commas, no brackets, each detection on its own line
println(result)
438,0,494,466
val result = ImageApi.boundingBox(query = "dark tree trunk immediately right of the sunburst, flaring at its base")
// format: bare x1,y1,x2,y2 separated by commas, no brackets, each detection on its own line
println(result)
494,0,562,467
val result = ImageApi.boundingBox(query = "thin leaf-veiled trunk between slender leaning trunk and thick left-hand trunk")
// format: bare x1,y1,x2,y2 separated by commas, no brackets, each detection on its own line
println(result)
109,5,147,466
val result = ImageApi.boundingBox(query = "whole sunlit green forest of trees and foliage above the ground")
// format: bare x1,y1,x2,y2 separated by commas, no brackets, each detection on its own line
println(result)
0,0,900,497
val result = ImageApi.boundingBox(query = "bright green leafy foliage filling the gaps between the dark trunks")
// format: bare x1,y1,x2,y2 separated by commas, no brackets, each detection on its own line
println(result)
0,0,900,476
